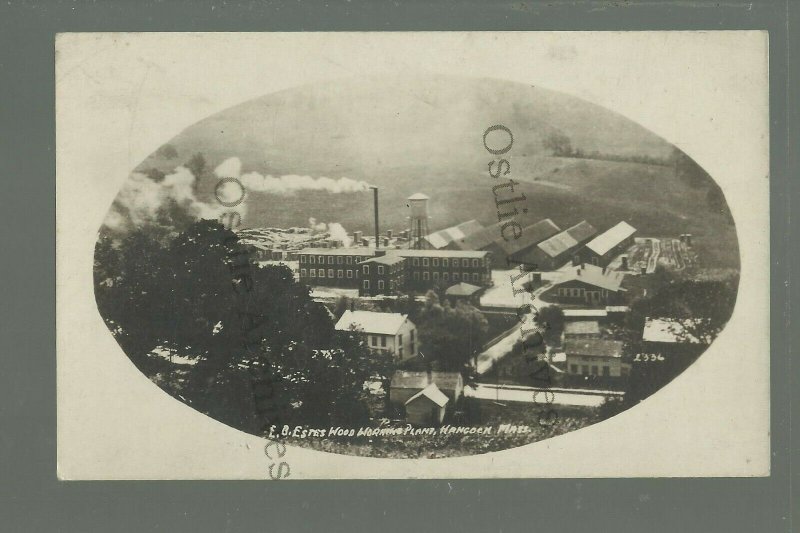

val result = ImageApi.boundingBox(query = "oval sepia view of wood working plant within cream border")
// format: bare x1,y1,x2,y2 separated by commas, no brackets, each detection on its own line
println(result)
94,75,740,458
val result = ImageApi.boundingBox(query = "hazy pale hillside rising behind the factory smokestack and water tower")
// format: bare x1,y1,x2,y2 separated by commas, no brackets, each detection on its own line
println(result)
131,76,738,266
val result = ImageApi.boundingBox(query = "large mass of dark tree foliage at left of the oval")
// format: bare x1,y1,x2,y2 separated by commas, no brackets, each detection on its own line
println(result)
95,220,389,431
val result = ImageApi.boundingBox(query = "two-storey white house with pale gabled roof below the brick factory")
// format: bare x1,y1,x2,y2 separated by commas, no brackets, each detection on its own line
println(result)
336,310,419,361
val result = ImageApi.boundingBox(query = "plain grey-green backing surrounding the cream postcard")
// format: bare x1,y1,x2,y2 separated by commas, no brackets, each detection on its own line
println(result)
0,0,800,532
